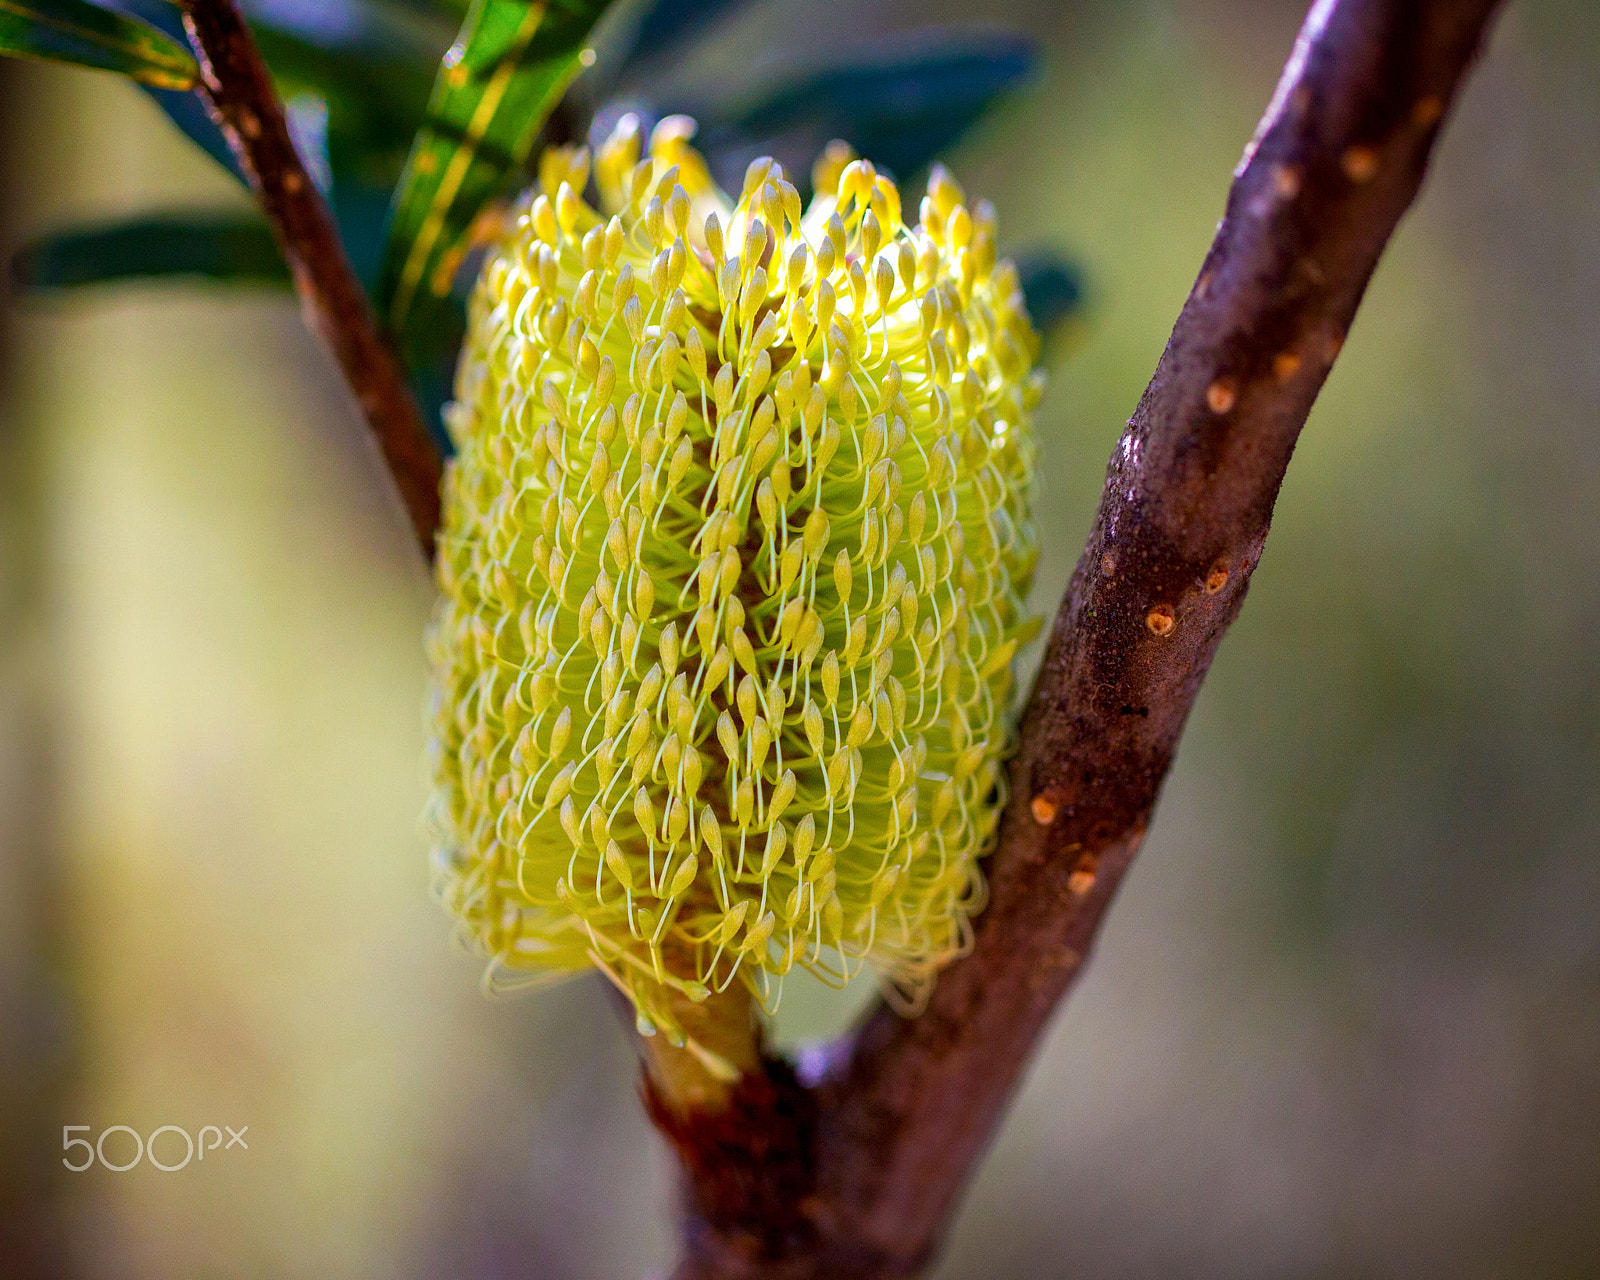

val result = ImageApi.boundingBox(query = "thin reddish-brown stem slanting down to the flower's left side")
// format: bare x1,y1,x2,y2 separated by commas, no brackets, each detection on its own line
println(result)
181,0,443,558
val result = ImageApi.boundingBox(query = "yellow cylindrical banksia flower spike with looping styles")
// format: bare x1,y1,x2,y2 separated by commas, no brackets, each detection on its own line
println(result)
430,117,1040,1066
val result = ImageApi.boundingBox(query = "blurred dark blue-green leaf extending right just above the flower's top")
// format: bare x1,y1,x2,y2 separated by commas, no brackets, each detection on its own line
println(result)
685,29,1038,192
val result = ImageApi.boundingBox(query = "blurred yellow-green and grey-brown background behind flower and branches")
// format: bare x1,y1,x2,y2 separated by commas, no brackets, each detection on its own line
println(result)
0,0,1600,1280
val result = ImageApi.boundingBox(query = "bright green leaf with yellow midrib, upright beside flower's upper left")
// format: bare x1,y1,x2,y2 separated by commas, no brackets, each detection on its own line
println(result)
381,0,608,347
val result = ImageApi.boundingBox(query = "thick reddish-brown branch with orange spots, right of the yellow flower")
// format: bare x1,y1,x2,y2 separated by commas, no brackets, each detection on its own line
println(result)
667,0,1496,1280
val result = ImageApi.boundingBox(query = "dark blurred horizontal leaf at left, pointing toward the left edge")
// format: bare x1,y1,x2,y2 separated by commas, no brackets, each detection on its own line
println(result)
11,213,290,293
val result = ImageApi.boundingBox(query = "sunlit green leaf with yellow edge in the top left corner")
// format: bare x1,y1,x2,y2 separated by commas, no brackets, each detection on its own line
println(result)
0,0,200,90
